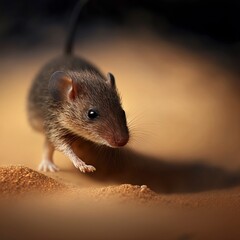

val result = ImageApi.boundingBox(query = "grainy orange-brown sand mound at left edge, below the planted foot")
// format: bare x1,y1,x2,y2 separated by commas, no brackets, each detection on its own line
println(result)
0,166,64,195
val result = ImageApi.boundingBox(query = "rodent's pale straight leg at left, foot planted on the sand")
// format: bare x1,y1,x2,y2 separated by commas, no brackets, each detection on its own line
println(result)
38,139,59,172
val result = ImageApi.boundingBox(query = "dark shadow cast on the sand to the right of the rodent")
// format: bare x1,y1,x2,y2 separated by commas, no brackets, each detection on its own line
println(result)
74,141,240,193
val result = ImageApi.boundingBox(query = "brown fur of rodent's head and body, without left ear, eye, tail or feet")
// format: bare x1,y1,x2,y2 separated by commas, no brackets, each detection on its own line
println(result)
28,56,129,151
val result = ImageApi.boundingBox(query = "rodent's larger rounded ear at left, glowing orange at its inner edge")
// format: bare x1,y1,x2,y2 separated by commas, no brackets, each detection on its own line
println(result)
48,71,77,101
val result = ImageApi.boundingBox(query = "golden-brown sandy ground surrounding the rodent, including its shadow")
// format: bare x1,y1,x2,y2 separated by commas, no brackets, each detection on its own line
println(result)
0,26,240,239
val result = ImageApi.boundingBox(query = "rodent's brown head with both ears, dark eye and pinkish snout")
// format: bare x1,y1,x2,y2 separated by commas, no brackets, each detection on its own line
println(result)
49,70,129,147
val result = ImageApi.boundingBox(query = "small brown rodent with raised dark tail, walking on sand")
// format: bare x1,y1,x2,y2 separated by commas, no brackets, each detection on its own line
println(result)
28,2,129,173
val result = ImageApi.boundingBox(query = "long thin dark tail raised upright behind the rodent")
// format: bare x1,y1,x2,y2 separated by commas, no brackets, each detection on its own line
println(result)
64,0,88,55
